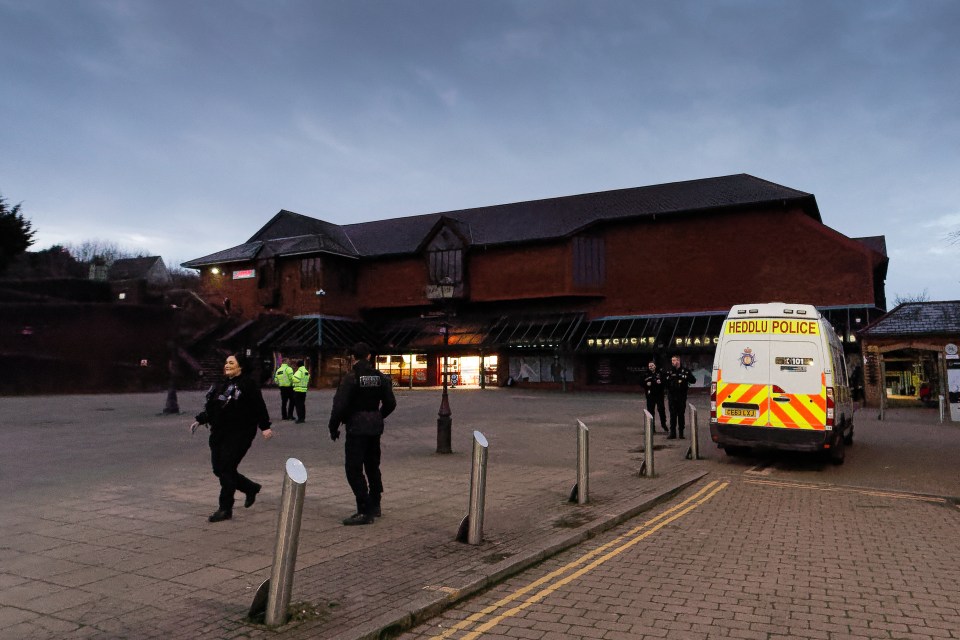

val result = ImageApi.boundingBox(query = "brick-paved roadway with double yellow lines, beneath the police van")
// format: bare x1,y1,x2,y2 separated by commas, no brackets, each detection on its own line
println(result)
401,412,960,640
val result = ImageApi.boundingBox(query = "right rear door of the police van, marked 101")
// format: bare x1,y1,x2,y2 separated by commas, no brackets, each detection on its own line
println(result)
769,336,827,430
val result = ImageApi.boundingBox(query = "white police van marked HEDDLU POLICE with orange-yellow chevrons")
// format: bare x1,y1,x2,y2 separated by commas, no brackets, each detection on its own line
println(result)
710,302,854,464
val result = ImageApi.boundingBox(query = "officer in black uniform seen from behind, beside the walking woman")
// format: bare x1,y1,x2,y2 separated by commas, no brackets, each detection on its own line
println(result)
328,342,397,526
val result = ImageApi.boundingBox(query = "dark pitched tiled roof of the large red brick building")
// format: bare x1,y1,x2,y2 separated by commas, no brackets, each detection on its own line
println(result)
183,174,821,267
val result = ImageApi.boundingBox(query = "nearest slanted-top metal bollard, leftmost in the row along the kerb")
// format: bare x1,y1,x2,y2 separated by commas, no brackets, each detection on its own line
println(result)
264,458,307,626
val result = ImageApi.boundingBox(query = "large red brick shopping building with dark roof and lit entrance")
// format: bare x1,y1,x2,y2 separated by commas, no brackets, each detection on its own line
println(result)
183,174,888,388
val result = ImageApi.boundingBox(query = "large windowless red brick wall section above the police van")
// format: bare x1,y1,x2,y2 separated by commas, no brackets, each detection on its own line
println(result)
592,210,873,316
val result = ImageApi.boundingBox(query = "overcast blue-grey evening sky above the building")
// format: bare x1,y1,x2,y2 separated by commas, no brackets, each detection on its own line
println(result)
0,0,960,302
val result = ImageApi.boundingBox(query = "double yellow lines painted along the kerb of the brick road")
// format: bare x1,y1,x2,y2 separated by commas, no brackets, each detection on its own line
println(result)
433,480,730,640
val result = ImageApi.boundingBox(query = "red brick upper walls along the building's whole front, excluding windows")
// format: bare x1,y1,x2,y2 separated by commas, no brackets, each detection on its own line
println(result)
202,209,876,318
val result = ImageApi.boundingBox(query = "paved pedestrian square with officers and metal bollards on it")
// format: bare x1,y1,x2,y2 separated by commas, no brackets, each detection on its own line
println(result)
0,389,704,639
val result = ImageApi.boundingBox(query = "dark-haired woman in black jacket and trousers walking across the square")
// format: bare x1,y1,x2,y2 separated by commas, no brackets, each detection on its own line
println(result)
197,354,273,522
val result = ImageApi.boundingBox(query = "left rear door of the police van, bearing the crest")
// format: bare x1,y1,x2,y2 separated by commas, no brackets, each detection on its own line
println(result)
717,334,771,427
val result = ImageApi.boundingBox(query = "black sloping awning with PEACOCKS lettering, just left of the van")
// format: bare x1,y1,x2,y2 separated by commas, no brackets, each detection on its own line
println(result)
576,311,727,351
